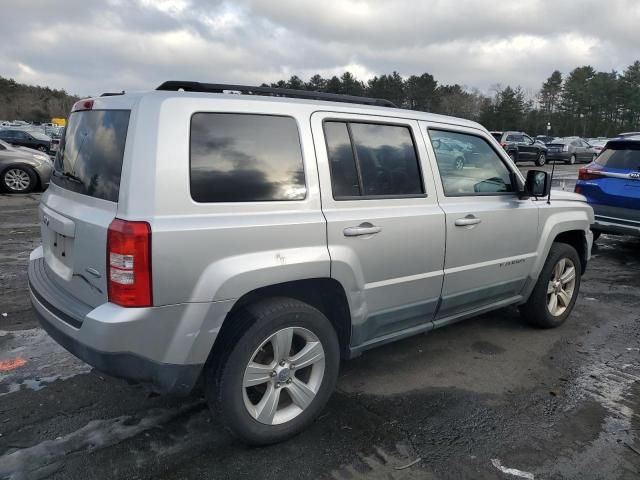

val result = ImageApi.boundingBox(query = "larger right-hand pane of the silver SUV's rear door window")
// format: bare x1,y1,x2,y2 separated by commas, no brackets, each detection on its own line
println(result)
349,123,424,196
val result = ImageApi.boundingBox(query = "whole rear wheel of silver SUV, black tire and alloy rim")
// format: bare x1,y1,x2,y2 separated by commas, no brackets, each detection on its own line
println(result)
205,297,340,445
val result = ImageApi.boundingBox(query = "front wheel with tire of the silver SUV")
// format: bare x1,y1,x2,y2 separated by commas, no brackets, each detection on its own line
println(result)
520,243,582,328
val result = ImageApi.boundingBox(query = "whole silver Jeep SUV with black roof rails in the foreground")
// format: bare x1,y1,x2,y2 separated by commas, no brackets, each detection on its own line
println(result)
29,82,593,444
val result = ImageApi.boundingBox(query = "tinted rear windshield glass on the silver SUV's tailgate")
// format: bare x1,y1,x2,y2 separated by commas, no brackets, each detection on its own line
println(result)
51,110,130,202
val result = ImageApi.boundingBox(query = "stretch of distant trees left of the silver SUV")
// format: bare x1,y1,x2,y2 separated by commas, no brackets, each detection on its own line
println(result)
0,76,78,122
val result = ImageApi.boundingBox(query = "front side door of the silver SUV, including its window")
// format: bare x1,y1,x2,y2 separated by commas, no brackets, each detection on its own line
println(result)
421,122,538,325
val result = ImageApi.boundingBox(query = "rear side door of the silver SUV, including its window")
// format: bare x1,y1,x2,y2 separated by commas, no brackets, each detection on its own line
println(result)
311,112,445,347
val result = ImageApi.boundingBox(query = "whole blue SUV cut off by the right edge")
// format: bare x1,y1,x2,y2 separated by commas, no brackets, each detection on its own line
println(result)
575,136,640,238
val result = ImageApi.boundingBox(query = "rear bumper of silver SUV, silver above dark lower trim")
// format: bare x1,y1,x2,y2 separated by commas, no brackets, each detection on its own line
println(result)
29,249,232,395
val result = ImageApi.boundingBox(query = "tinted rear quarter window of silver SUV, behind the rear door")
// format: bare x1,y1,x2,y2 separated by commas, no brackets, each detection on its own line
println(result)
190,113,307,202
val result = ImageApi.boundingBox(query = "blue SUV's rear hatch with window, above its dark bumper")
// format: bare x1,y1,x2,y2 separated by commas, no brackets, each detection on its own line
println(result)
579,140,640,209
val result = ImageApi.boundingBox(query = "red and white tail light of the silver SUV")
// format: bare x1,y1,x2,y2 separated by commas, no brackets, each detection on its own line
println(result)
107,218,153,307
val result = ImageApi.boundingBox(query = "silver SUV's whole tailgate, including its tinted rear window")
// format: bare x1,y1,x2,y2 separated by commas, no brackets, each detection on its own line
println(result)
40,110,130,307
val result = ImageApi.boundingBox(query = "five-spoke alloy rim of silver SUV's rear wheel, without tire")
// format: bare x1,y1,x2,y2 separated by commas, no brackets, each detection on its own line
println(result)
242,327,325,425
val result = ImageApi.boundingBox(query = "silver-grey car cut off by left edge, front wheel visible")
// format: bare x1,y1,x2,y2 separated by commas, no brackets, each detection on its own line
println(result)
0,140,53,193
